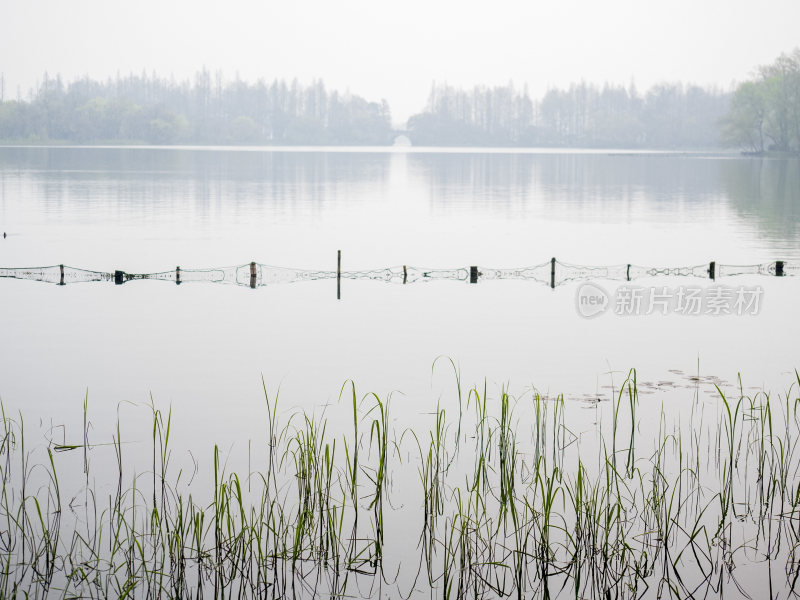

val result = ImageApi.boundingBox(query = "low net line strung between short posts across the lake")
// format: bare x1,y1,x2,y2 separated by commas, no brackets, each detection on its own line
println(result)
0,259,800,288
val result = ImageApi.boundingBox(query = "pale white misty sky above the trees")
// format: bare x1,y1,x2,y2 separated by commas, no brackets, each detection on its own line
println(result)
0,0,800,122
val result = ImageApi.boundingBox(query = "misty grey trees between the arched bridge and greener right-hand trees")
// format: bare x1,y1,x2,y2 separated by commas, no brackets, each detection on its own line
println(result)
408,83,730,148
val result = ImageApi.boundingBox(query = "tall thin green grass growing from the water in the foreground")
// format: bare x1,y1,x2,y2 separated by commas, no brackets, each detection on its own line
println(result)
0,363,800,599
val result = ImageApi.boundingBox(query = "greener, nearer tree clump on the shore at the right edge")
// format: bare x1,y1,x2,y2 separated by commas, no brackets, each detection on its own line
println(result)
722,48,800,153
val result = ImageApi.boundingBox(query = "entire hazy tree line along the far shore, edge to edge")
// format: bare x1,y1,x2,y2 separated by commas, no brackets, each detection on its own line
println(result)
0,49,800,152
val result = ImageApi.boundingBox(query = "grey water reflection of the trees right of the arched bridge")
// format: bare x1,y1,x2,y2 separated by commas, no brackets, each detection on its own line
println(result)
410,154,725,220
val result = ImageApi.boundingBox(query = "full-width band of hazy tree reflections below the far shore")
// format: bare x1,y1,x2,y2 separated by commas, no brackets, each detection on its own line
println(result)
0,147,800,261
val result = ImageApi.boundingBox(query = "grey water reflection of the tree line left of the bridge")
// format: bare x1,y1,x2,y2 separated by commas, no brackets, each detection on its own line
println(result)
0,148,391,223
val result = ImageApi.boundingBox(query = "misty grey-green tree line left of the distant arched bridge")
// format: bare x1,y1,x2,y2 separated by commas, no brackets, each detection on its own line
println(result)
0,70,393,144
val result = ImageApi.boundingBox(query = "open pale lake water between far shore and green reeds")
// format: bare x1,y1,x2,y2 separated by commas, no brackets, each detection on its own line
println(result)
0,147,800,600
